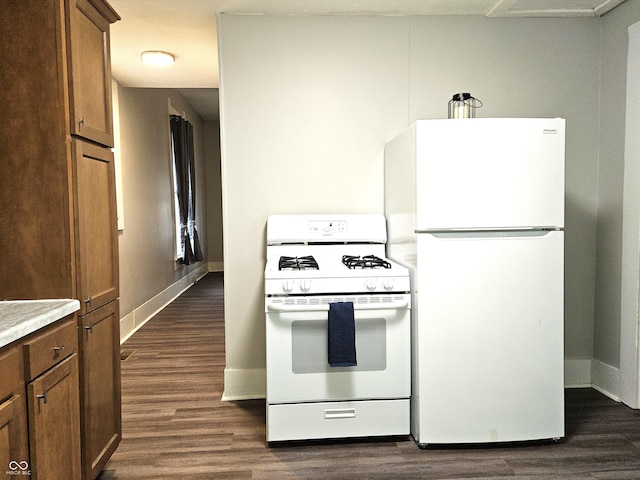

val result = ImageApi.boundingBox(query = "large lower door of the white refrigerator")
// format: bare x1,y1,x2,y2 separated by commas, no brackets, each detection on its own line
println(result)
412,231,564,444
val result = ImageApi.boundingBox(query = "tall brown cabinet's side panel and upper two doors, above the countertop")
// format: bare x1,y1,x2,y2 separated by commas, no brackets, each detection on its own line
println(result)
0,0,118,304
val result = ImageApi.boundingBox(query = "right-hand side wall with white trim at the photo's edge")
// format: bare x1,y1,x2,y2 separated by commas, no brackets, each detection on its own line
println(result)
594,1,640,407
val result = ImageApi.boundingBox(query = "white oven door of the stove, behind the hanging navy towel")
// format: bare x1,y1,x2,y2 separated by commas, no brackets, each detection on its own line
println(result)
266,294,411,404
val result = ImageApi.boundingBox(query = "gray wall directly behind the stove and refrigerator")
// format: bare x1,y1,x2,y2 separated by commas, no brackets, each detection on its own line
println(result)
218,15,600,398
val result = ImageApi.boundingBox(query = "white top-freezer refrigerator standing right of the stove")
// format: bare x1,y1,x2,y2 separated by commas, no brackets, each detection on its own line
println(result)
385,118,565,446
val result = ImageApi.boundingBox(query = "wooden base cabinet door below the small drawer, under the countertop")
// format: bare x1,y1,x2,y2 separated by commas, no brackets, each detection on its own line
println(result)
27,353,81,480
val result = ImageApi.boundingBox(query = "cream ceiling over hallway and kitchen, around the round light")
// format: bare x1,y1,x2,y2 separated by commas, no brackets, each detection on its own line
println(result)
108,0,625,120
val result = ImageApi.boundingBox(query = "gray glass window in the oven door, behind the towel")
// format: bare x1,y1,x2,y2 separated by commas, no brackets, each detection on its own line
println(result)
291,318,387,374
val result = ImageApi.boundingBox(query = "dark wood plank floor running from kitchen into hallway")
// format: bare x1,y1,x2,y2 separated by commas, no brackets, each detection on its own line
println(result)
99,274,640,480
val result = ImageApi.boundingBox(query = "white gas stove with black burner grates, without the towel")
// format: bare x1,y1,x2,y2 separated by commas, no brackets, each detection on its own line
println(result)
264,214,411,442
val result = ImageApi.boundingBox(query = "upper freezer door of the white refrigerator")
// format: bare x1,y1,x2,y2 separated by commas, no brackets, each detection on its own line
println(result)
413,118,565,231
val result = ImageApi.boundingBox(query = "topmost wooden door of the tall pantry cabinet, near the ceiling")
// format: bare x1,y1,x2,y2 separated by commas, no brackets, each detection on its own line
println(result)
67,0,117,146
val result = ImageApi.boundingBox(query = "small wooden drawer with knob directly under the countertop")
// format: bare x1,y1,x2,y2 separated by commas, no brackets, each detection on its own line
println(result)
24,317,78,380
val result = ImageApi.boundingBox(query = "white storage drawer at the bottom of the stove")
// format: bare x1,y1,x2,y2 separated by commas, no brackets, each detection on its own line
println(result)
267,398,409,442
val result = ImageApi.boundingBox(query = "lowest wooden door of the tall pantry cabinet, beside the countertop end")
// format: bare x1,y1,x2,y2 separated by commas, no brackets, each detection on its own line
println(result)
80,300,122,479
